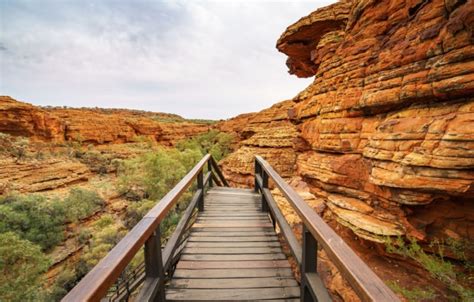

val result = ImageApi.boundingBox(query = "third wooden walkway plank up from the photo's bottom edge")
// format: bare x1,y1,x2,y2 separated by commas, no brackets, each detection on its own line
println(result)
173,268,293,279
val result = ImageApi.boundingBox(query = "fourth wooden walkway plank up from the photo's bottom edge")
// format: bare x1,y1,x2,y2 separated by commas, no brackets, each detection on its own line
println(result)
176,260,291,269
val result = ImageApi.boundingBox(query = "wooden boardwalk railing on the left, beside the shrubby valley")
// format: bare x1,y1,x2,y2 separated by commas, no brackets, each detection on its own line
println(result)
63,154,228,301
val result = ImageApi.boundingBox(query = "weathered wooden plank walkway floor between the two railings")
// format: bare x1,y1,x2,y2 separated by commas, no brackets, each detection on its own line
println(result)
166,187,300,301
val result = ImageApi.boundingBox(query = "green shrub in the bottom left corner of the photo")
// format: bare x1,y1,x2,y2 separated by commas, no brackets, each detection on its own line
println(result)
0,232,49,301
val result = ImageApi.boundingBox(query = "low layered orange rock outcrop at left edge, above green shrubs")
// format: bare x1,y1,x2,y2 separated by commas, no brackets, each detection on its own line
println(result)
0,159,91,195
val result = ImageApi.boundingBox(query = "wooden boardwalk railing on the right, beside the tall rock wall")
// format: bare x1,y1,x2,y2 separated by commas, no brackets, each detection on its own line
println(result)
255,156,399,302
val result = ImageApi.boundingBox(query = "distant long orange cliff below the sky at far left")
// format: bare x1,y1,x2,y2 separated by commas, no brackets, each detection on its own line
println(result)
0,97,210,145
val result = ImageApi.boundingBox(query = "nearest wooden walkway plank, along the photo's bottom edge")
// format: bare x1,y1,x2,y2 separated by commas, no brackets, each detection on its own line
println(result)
166,287,300,301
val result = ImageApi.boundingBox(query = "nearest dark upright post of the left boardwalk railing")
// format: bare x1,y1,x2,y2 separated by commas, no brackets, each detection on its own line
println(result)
145,225,165,301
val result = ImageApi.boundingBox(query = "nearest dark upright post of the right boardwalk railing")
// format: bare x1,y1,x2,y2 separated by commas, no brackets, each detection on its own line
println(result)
301,223,318,302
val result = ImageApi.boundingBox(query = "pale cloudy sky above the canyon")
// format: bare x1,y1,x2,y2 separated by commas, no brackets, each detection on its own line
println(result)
0,0,334,119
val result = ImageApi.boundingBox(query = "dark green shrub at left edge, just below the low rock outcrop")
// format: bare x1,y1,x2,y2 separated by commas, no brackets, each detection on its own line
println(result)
0,195,66,250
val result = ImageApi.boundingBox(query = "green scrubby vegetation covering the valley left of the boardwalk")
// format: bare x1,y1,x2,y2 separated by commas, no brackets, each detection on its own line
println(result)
0,131,233,301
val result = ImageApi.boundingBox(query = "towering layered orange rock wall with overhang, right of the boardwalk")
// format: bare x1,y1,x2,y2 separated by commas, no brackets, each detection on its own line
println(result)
221,0,474,258
